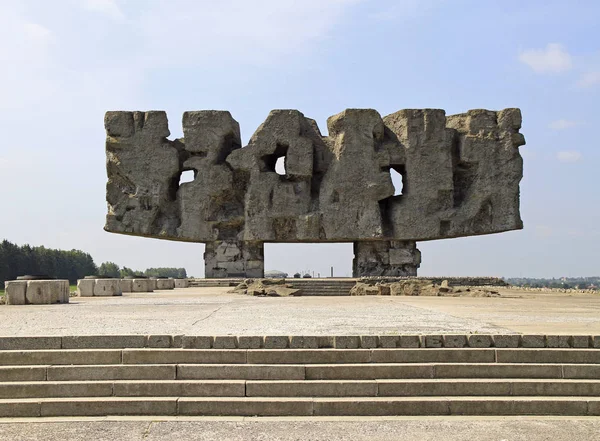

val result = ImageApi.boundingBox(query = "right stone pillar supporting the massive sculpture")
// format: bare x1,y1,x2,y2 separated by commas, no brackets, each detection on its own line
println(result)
352,240,421,277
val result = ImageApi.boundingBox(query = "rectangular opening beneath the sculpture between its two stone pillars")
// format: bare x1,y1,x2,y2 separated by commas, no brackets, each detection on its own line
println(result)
265,243,354,279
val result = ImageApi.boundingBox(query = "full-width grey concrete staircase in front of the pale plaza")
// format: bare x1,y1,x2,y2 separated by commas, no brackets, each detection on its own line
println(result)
0,335,600,417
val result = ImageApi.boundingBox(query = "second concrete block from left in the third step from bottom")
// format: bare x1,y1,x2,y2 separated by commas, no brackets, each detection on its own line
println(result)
47,364,176,381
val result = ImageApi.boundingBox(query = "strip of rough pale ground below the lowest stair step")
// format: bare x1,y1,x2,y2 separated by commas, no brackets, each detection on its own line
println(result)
0,417,600,441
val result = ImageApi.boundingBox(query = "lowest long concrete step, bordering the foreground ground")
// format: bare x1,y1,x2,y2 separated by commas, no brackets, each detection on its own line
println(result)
0,397,600,417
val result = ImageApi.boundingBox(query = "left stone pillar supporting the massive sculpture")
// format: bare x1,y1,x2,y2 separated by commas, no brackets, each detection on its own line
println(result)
204,240,265,279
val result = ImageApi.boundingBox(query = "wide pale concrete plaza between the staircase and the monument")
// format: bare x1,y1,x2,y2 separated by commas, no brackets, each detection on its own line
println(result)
0,288,600,336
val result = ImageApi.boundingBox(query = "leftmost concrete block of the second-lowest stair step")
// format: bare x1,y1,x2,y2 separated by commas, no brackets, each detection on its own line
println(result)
0,381,113,399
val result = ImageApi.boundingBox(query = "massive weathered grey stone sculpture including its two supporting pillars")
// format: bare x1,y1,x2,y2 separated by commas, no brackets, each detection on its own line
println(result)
105,109,525,277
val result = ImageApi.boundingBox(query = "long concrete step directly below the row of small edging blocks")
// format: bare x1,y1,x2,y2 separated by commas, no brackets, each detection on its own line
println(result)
0,348,600,366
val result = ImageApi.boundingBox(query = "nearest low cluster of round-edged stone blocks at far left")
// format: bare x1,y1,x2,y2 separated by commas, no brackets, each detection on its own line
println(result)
4,276,70,305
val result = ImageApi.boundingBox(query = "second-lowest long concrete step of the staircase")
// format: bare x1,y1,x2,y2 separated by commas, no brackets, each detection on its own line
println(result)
0,379,600,399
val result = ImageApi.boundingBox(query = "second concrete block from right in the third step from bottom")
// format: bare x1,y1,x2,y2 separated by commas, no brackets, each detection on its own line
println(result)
434,363,562,378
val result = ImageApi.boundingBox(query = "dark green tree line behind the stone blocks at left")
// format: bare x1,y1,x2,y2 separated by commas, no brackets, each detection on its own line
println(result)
0,240,187,289
